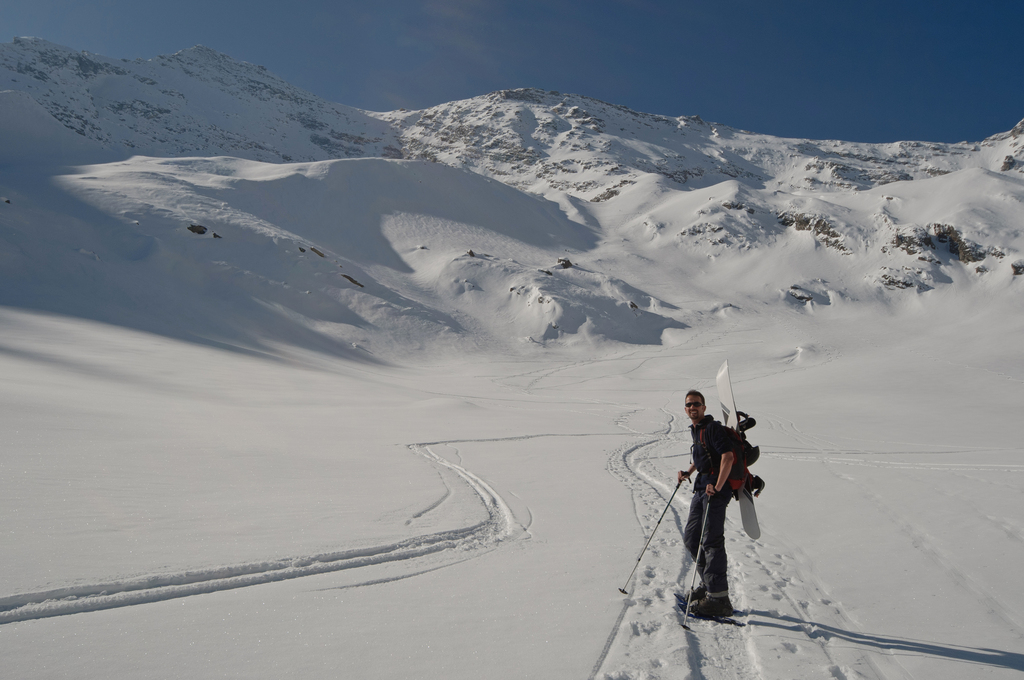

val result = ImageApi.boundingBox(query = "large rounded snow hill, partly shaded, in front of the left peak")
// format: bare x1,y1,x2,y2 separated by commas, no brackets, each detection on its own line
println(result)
8,157,685,358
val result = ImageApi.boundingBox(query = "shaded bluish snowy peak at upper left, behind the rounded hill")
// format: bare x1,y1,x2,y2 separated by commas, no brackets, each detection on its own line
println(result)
0,38,398,163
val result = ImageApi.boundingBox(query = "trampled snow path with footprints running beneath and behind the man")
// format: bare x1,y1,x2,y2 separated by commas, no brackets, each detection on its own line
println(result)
589,366,909,680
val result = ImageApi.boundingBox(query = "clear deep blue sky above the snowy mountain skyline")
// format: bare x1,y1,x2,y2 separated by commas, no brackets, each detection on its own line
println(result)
0,0,1024,141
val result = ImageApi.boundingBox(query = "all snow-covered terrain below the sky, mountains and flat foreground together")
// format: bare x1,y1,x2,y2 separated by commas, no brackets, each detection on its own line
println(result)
0,39,1024,679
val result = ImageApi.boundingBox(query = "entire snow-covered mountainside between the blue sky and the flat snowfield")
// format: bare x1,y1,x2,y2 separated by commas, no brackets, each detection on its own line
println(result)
0,39,1024,358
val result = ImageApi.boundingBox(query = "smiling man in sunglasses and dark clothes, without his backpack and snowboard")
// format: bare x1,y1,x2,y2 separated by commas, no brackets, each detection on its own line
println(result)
679,389,736,617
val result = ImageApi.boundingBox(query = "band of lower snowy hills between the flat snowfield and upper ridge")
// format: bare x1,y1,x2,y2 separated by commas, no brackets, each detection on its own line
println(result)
0,142,1024,362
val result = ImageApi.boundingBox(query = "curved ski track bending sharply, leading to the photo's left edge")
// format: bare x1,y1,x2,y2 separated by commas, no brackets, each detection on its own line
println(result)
0,442,525,625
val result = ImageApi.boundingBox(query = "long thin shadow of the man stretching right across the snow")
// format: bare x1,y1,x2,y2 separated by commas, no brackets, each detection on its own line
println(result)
748,609,1024,671
